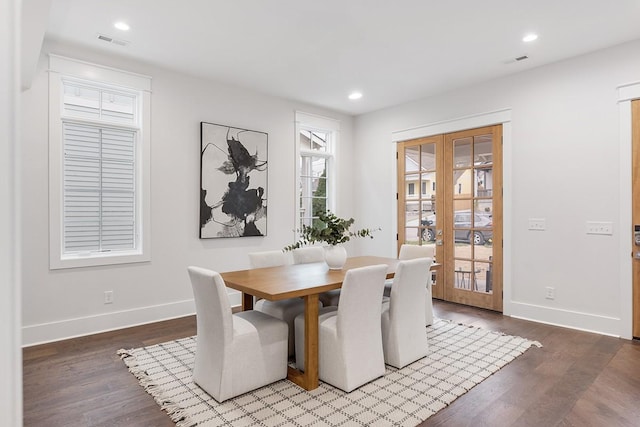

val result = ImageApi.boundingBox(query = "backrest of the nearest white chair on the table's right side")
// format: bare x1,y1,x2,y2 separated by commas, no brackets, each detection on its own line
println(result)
336,264,387,347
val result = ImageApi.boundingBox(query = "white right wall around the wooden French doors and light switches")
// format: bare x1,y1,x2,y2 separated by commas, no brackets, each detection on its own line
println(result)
355,42,640,337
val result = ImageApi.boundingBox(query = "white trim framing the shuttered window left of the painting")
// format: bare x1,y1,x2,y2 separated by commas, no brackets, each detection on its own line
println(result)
49,55,151,270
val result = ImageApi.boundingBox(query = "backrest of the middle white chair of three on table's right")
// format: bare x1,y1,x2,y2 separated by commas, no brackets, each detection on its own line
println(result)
389,258,433,329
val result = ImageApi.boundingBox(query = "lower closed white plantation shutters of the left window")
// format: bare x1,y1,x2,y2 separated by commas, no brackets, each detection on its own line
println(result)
63,123,136,253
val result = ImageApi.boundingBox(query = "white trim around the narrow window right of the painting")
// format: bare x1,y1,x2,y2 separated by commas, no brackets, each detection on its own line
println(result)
294,111,340,234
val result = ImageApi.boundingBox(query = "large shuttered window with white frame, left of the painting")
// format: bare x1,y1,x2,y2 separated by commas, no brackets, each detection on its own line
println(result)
49,55,150,269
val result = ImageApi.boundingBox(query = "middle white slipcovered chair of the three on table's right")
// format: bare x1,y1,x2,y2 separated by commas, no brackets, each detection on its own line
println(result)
382,258,433,369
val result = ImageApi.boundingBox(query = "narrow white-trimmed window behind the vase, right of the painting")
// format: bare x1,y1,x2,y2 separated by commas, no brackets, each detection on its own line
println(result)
296,112,340,228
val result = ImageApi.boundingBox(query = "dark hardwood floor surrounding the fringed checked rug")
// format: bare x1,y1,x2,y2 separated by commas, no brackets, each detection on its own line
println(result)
23,301,640,427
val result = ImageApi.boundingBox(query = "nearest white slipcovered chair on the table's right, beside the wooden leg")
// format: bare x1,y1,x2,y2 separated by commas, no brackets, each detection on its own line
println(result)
295,264,387,392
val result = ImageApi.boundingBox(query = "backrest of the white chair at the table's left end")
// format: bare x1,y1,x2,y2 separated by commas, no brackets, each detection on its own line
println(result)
187,267,233,345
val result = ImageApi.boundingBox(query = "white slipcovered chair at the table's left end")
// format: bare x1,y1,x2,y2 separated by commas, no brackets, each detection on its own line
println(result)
188,267,288,402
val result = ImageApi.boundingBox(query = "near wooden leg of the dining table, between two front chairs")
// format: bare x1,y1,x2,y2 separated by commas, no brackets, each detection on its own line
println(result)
287,294,319,390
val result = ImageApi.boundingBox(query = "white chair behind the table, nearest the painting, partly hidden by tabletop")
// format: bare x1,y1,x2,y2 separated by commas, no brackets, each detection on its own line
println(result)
249,251,316,356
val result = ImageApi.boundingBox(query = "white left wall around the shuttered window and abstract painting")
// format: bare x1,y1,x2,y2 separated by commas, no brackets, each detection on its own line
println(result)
22,41,354,345
